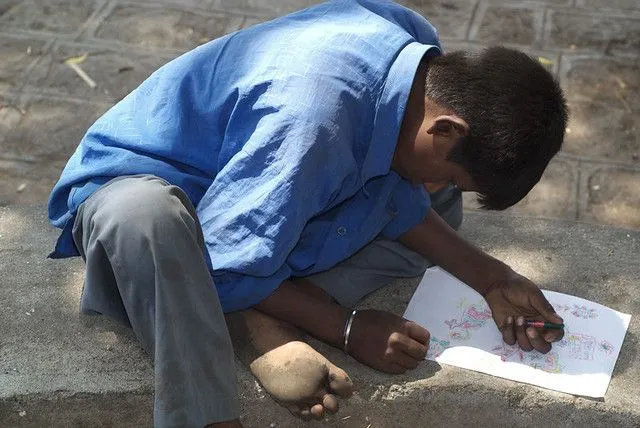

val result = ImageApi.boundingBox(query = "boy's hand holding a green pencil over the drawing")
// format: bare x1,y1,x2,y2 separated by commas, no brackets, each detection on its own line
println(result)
485,269,564,353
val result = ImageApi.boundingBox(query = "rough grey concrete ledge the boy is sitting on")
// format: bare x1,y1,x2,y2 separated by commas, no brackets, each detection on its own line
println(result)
0,207,640,428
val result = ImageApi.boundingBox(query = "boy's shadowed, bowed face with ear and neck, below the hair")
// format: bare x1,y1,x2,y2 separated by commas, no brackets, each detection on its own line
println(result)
391,90,476,191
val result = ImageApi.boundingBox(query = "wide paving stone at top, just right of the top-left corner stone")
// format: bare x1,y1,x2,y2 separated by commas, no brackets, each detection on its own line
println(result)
96,5,245,50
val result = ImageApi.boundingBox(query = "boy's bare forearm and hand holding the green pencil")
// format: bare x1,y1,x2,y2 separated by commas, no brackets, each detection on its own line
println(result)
399,209,564,352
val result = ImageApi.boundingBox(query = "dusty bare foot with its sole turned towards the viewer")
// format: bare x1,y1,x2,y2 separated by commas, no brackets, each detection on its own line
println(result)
227,309,353,420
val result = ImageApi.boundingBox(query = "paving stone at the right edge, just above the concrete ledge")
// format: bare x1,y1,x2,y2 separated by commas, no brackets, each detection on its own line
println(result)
580,168,640,228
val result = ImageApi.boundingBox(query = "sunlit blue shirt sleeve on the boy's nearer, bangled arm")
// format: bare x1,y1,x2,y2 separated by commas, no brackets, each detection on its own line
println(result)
197,106,358,312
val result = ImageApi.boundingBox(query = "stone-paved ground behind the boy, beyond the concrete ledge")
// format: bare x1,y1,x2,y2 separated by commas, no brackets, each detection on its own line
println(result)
0,0,640,229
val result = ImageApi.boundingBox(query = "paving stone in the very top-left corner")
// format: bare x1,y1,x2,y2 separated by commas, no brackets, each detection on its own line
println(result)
0,0,99,34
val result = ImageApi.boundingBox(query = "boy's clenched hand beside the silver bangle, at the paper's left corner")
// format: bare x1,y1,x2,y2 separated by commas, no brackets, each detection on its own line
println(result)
348,309,430,374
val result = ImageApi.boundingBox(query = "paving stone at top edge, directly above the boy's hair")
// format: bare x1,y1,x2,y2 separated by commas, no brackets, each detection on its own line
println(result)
398,0,477,40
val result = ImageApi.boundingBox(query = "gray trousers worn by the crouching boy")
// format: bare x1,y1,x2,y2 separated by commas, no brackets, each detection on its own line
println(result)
73,175,462,427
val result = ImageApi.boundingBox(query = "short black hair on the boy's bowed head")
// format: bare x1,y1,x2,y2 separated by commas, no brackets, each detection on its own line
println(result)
425,47,567,210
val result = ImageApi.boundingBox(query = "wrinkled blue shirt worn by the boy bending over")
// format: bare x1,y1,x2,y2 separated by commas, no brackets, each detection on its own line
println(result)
49,0,440,312
